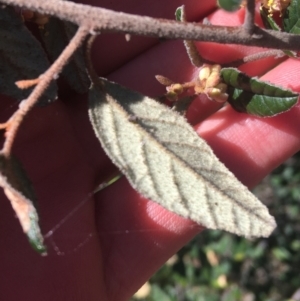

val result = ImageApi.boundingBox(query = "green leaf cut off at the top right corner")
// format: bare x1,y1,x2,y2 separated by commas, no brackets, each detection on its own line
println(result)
283,0,300,34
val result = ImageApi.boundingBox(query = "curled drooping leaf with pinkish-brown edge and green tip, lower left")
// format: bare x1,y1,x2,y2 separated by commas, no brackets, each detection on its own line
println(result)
0,153,46,255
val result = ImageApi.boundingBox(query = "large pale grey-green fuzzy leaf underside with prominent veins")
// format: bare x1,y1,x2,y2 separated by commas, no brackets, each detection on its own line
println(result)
89,79,276,237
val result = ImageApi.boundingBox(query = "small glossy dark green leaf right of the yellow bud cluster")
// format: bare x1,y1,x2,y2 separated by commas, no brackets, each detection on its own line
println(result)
221,68,299,117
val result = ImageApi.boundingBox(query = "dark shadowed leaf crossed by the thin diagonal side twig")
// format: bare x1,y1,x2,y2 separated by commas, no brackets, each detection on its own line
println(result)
40,18,91,94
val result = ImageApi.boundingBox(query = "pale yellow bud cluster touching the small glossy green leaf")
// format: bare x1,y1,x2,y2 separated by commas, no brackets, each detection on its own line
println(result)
194,64,228,103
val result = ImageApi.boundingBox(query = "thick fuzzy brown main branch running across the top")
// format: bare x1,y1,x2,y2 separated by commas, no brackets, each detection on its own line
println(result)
0,0,300,51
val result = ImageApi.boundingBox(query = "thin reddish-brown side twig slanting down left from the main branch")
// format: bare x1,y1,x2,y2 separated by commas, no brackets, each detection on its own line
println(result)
2,25,91,156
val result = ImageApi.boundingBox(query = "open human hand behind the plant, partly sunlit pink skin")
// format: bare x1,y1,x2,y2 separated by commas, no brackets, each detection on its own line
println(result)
0,0,300,301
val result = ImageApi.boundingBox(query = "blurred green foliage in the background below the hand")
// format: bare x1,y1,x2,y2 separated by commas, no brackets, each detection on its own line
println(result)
131,153,300,301
